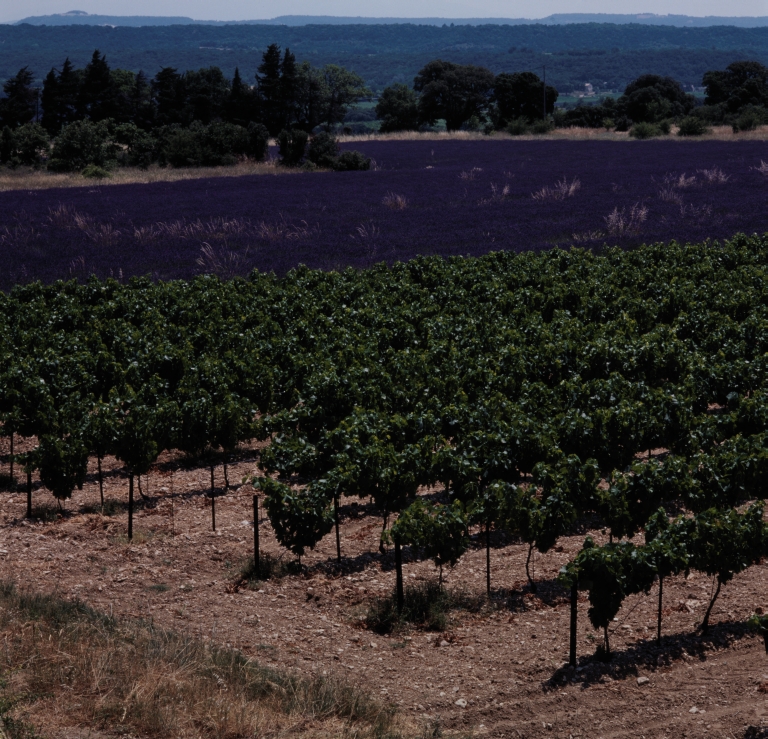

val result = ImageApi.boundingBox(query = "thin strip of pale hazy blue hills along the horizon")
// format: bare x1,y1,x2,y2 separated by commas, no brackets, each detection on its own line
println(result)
14,10,768,28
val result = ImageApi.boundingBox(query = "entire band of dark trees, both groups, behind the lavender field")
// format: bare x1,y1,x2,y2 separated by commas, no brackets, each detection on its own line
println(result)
0,49,768,173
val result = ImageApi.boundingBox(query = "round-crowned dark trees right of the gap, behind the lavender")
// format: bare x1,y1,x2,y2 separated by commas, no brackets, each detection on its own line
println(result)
376,60,768,136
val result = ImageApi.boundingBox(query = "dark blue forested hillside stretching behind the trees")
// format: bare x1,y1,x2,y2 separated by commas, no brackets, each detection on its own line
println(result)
0,20,768,92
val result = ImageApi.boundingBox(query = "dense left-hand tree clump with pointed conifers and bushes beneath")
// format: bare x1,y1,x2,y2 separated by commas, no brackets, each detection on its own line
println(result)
0,44,370,171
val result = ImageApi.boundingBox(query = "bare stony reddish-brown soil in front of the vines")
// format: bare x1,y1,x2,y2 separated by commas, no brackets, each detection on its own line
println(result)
0,439,768,739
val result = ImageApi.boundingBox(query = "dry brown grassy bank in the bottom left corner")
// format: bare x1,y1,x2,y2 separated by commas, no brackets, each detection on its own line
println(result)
0,585,399,739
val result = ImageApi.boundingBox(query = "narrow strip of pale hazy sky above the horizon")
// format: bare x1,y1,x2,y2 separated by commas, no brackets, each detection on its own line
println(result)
0,0,768,22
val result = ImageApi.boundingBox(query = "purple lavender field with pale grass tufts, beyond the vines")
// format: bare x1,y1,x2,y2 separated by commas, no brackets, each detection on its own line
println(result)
0,140,768,289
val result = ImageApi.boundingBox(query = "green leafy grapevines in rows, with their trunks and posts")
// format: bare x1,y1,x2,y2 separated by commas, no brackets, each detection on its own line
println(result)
0,228,768,680
